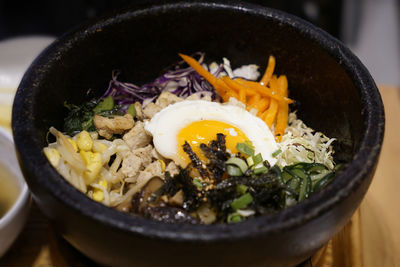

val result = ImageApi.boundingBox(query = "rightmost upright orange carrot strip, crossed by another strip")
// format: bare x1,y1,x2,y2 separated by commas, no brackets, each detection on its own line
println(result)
275,75,289,142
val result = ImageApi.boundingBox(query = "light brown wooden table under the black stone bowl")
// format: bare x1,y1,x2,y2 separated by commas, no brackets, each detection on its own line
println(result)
0,86,400,267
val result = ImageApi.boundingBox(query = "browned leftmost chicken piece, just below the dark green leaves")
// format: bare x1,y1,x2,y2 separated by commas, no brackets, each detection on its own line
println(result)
93,114,135,139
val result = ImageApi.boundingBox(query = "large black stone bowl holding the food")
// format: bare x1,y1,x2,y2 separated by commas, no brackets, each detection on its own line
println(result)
12,2,384,266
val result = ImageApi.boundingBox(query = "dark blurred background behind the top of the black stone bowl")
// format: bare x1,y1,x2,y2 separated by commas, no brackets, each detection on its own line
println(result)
0,0,400,85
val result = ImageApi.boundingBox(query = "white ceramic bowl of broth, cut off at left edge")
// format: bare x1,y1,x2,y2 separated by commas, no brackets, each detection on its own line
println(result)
0,127,30,257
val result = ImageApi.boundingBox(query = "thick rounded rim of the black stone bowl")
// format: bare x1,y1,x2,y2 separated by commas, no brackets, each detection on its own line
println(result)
12,1,385,242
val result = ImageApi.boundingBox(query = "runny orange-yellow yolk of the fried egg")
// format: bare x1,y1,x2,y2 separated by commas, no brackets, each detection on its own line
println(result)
177,120,248,167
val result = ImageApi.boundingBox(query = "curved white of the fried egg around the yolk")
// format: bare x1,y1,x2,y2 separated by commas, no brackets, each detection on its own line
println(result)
145,100,278,166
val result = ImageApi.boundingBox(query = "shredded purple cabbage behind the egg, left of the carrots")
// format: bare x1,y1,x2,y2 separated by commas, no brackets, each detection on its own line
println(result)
101,52,223,112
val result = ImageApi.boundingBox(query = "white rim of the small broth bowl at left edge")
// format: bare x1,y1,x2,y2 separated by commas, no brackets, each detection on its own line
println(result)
0,127,29,230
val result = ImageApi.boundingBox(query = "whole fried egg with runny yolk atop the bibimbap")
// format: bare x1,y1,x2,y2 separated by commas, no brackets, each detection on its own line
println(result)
145,100,278,167
